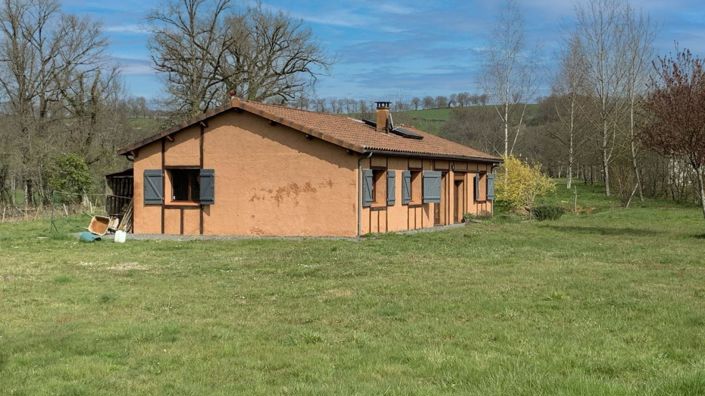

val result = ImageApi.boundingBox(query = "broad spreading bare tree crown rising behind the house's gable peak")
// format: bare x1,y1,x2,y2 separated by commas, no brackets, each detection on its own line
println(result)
148,0,329,116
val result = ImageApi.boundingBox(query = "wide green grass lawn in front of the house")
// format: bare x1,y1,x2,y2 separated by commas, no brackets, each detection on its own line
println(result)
0,186,705,395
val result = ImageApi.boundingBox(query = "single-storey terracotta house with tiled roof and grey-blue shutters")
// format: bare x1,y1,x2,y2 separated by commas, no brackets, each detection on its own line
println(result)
119,98,501,237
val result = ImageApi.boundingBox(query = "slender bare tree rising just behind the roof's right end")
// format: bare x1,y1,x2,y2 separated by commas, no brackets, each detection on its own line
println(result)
481,0,535,156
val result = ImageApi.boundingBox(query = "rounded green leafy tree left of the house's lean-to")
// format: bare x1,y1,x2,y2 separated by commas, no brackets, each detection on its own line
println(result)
49,154,91,203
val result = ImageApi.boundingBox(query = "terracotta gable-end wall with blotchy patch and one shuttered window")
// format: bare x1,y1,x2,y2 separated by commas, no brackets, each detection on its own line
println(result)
135,111,357,236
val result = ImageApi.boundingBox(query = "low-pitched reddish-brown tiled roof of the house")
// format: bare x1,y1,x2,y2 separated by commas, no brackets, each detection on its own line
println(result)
119,99,501,162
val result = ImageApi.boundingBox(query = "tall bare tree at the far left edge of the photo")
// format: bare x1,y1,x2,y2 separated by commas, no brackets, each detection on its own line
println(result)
0,0,107,203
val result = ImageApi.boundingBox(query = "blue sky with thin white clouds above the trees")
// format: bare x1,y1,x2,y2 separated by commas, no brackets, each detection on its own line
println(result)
63,0,705,100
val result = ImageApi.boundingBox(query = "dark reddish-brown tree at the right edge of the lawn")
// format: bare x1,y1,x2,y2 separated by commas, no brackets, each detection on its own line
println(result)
641,50,705,220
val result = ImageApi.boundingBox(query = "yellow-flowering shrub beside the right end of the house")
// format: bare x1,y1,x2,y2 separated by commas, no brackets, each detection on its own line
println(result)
496,156,556,214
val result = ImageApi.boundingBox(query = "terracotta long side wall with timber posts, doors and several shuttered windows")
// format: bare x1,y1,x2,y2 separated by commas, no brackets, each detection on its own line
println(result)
362,156,492,234
